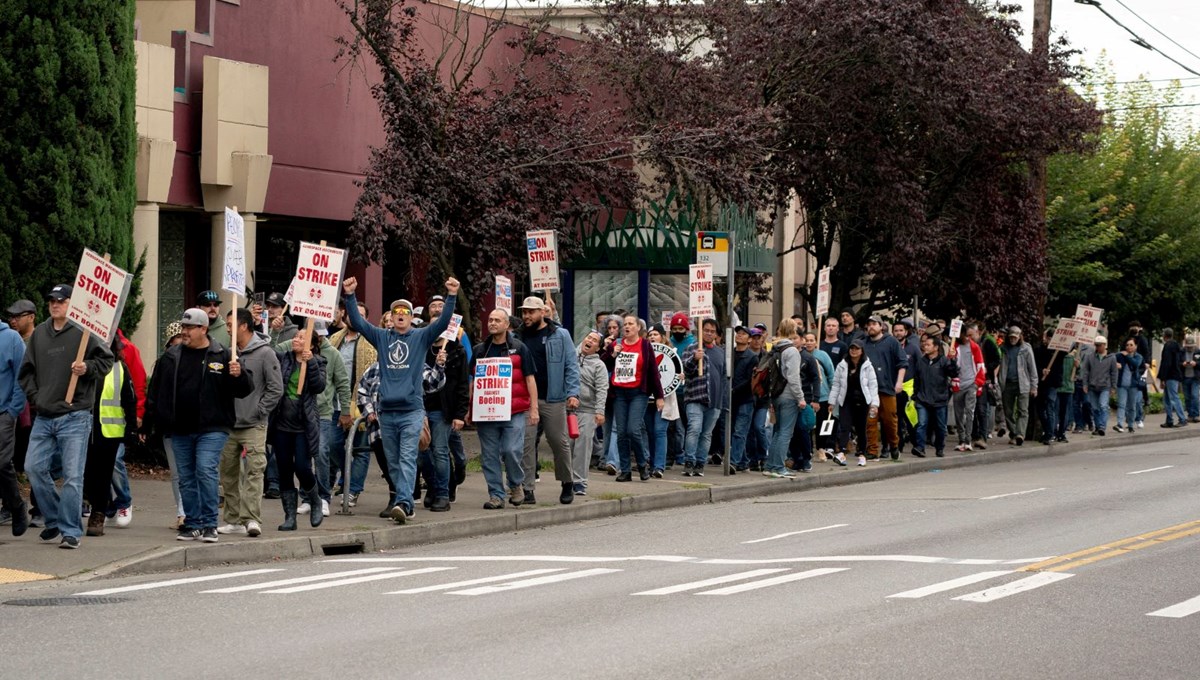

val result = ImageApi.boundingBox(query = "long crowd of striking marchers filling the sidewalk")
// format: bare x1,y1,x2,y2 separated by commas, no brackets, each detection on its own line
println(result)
0,278,1200,548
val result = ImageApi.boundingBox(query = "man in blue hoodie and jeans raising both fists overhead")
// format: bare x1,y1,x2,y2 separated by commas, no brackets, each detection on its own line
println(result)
342,276,458,524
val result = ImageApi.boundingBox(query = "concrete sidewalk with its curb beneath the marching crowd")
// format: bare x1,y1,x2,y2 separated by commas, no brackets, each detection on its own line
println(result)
0,415,1200,584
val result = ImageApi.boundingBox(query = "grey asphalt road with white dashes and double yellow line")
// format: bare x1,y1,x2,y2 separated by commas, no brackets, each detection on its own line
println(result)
0,440,1200,679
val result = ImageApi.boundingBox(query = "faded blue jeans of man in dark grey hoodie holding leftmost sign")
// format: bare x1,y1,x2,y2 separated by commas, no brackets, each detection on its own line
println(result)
26,411,93,538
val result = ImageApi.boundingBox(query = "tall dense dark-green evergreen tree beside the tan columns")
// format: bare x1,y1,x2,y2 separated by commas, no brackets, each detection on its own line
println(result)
0,0,140,330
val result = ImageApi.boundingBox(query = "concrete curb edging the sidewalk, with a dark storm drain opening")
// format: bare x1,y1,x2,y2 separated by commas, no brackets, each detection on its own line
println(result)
88,427,1200,580
